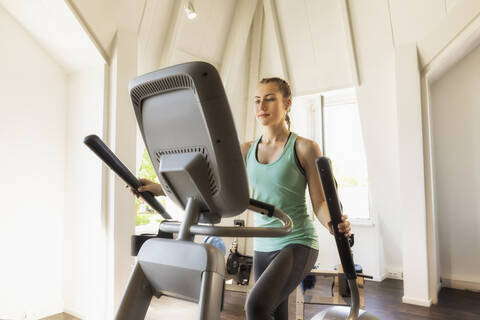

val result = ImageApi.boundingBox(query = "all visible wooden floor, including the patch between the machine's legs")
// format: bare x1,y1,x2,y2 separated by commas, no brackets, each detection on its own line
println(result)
46,278,480,320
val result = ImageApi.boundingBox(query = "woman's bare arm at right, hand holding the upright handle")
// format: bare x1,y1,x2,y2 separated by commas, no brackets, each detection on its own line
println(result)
296,137,351,236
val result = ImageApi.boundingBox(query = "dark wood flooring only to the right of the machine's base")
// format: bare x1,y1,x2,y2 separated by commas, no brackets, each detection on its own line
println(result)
222,278,480,320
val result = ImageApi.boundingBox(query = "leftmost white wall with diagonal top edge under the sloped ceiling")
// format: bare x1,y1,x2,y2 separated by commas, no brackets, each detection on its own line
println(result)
0,7,66,319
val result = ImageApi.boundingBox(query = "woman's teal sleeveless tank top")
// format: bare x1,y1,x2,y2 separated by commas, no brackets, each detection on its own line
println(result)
246,132,318,252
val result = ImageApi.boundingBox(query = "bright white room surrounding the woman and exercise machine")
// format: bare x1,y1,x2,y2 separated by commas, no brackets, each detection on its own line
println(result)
0,0,480,320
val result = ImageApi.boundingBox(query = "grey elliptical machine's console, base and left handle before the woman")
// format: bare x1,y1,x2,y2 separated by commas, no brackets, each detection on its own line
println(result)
84,62,292,320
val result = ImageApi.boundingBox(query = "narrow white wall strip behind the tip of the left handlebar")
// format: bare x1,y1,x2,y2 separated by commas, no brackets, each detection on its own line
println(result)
63,65,106,319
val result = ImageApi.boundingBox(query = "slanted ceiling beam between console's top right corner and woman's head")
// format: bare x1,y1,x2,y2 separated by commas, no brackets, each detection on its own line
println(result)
220,0,258,92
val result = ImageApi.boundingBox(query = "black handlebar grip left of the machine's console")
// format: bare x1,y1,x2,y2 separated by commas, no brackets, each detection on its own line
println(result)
83,134,172,219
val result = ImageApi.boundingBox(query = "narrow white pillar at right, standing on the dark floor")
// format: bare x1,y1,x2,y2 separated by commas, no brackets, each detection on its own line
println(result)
395,42,434,306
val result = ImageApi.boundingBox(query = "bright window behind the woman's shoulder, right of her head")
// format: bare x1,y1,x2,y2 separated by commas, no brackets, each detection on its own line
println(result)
291,88,370,223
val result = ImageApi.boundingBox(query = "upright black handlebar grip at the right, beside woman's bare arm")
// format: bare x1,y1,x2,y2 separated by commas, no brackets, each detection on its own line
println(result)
315,157,357,280
